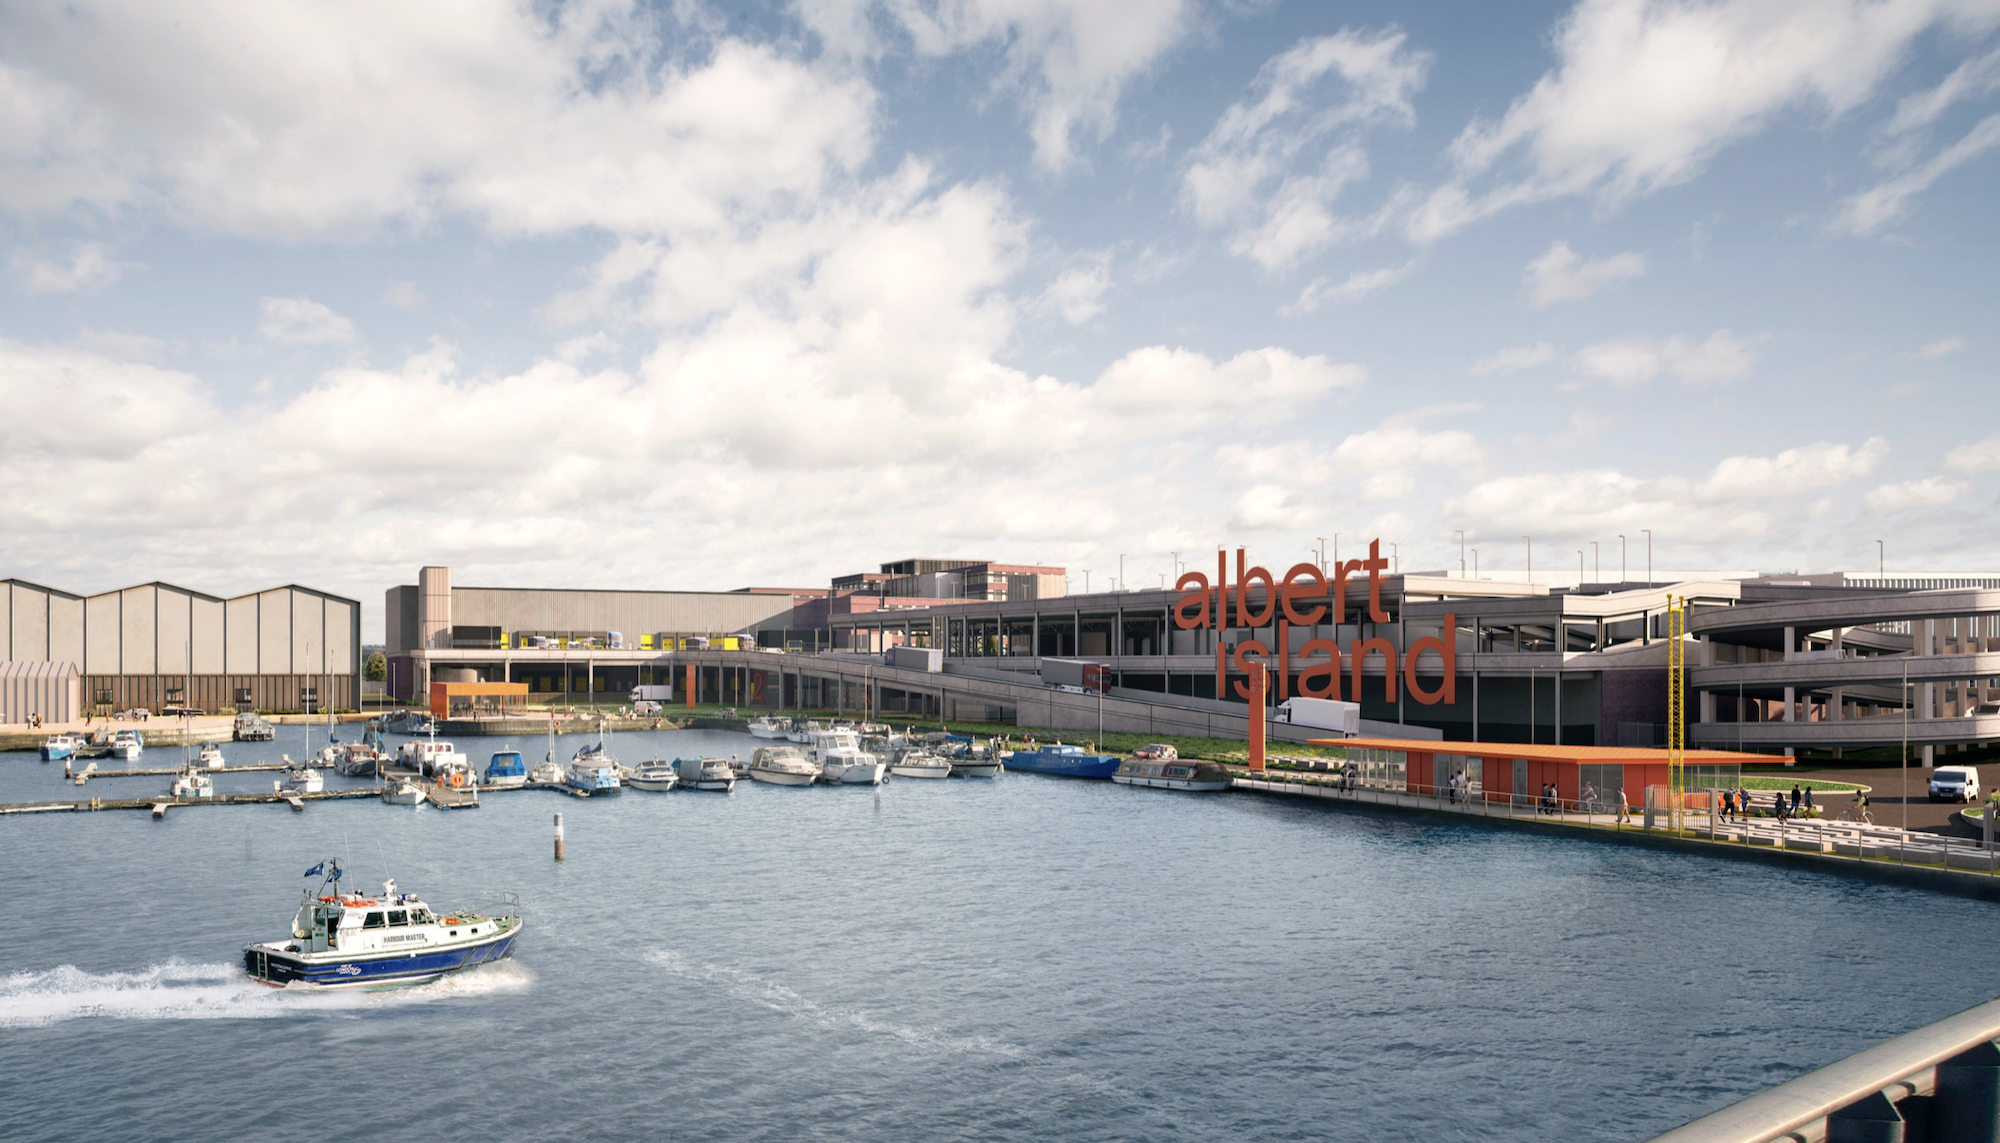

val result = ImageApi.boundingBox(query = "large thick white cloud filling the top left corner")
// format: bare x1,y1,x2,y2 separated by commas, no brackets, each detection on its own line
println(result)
0,0,874,240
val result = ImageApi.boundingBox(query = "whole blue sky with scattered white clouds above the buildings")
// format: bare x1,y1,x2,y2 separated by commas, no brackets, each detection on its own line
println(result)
0,0,2000,631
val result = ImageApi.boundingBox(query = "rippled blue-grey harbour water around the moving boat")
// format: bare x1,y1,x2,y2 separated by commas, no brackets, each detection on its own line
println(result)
0,727,2000,1141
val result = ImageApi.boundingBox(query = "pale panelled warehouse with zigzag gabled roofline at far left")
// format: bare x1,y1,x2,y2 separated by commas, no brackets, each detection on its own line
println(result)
0,579,362,717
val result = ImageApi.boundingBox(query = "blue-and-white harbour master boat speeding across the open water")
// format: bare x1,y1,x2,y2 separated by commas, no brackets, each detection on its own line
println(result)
244,861,520,989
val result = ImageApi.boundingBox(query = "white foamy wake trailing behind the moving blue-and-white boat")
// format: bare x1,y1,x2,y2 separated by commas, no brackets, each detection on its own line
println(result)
0,961,534,1027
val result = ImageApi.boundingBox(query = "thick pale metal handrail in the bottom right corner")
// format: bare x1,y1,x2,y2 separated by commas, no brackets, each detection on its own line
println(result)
1648,999,2000,1143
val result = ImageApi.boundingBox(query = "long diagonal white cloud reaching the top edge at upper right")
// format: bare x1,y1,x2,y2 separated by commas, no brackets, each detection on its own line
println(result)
1408,0,1992,242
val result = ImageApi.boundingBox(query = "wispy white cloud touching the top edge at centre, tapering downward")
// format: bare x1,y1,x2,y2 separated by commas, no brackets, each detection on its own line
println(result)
798,0,1196,172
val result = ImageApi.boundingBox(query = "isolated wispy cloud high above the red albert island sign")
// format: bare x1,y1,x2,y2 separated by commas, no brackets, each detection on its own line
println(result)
1182,30,1430,270
